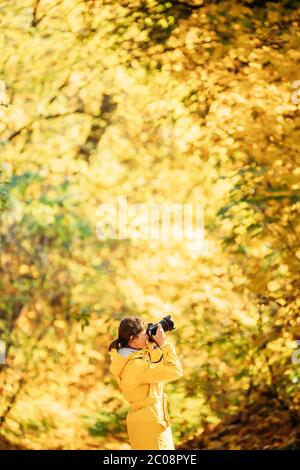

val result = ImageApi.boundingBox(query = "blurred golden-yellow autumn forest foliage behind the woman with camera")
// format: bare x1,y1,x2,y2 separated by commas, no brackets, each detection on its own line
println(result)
0,0,300,449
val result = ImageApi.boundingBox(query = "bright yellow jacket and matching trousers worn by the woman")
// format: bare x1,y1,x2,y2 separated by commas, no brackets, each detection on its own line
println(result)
110,343,183,450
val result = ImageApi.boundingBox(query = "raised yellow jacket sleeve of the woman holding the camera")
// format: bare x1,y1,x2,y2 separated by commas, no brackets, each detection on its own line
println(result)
134,343,183,383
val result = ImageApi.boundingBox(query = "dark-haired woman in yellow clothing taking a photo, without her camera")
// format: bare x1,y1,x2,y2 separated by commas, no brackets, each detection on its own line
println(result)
109,317,183,450
